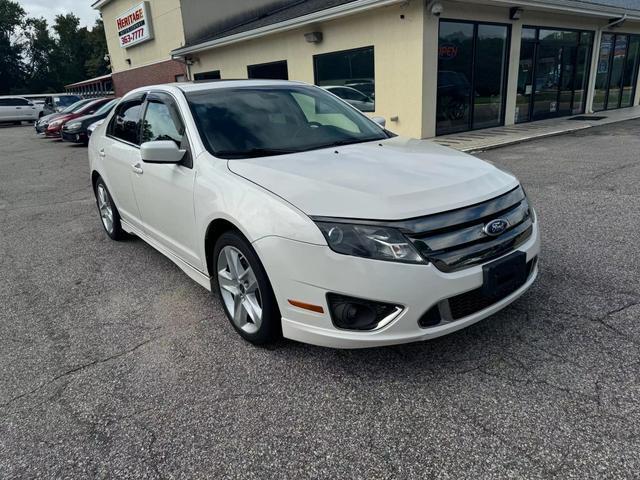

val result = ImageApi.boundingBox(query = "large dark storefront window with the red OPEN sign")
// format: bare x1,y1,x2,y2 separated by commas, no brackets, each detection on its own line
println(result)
436,20,509,135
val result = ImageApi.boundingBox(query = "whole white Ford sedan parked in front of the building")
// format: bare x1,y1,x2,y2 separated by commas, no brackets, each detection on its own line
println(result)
89,80,540,348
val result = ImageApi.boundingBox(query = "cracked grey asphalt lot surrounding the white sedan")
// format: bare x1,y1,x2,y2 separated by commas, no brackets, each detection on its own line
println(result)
0,121,640,479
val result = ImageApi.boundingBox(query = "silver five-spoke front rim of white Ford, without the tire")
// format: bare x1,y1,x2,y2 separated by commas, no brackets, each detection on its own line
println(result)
217,245,262,334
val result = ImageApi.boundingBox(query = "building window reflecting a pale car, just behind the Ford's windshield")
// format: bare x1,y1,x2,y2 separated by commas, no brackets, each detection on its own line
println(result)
313,47,376,112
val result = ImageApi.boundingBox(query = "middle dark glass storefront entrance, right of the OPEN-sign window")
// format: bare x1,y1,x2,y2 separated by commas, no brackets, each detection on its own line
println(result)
515,27,593,123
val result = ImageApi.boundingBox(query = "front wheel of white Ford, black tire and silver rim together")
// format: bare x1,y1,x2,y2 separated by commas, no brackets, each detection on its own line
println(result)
212,230,282,345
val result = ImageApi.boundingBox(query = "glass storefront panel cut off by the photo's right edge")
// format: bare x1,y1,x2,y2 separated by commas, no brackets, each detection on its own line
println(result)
593,33,640,111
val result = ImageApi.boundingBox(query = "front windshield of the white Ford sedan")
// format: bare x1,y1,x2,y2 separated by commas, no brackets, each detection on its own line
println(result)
187,85,389,158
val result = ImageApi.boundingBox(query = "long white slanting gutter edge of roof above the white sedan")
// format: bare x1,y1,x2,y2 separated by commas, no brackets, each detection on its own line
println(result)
172,0,406,57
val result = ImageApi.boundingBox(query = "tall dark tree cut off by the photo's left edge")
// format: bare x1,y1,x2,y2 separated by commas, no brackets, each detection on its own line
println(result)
0,0,25,95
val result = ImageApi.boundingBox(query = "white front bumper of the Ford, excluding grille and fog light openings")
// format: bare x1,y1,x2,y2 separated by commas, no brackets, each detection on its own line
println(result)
253,222,540,348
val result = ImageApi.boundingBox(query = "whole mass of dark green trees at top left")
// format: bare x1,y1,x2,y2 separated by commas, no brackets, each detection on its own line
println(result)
0,0,109,95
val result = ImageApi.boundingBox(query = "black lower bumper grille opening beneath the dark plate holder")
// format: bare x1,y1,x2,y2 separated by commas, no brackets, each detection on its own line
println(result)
418,257,537,328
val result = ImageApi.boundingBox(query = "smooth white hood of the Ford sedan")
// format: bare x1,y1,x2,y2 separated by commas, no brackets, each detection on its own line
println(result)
228,137,518,220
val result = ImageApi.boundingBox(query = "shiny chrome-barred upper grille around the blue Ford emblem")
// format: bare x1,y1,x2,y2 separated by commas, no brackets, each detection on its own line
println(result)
404,186,533,272
